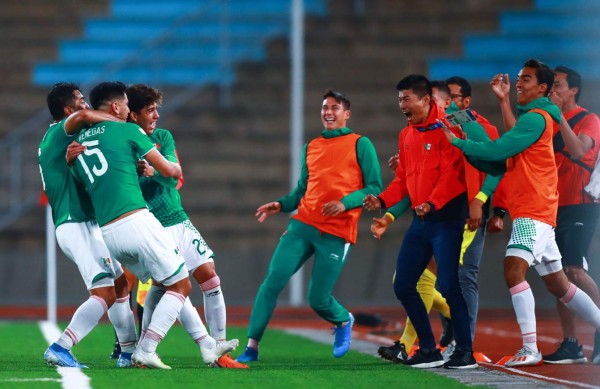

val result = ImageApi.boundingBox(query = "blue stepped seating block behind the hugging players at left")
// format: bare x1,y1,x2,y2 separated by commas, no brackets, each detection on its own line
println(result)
32,0,327,86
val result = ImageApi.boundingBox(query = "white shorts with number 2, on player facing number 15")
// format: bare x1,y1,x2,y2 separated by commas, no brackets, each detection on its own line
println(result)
167,219,214,272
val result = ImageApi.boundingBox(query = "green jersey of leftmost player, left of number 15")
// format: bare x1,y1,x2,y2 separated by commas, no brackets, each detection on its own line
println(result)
38,119,95,227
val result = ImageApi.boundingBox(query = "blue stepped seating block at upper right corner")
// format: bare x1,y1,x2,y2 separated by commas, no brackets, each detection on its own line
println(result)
428,0,600,82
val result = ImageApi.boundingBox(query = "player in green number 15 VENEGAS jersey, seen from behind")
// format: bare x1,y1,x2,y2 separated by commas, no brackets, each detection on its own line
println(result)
74,82,234,369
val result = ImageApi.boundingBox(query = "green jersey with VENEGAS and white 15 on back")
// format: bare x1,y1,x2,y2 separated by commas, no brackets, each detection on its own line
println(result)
74,122,154,226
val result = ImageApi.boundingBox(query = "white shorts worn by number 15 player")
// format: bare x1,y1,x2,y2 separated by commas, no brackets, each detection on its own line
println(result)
101,209,188,286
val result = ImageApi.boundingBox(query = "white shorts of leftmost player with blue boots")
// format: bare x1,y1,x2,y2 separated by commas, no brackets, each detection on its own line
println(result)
56,221,123,290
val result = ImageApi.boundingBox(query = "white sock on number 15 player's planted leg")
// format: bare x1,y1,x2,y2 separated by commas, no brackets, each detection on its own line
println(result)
140,291,186,353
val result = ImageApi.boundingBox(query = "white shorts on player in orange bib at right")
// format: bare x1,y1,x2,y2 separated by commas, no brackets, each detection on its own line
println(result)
506,217,562,276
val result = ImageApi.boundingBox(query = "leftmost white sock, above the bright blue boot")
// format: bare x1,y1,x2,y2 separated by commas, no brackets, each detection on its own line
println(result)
56,295,107,350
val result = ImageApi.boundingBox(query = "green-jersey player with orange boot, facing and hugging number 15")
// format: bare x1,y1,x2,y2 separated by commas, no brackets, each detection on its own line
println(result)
127,84,248,369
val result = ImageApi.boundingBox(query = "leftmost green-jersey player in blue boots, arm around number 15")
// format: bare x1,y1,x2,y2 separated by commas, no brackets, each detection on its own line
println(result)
38,83,136,367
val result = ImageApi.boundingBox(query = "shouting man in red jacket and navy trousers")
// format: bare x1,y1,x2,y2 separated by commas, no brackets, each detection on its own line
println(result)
364,74,478,369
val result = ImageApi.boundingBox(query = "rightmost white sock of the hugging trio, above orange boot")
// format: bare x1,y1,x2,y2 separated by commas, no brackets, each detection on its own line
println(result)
200,276,227,340
